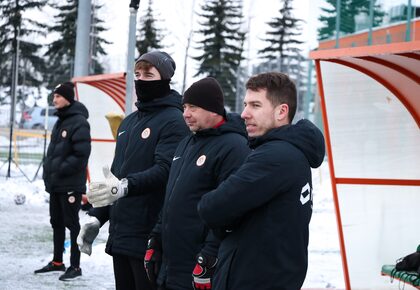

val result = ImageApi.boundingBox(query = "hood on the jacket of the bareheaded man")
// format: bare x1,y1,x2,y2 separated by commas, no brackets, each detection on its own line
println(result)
250,119,325,168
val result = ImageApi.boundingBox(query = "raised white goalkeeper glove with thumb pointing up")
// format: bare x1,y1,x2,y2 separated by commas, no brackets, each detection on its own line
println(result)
86,167,128,207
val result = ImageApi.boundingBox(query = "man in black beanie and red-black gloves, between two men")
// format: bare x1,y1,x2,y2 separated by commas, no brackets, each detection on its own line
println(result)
144,78,249,290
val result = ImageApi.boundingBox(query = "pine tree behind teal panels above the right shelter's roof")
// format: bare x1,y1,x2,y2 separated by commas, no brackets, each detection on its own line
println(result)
318,0,385,40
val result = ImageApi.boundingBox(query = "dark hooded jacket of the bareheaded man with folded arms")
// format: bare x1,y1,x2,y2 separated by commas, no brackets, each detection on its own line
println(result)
198,120,325,290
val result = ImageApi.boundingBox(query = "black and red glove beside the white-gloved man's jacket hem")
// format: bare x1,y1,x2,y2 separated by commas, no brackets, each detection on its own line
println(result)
144,235,162,285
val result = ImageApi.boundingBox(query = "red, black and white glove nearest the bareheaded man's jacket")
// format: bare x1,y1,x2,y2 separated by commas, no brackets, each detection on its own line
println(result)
193,253,217,290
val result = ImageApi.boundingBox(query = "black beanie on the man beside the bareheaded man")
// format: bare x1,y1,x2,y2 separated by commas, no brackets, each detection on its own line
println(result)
182,77,225,116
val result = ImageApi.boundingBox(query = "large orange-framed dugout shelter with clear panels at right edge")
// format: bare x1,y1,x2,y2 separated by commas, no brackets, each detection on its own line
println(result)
310,41,420,289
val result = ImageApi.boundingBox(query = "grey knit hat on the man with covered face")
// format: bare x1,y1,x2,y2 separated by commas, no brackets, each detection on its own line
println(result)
136,50,176,80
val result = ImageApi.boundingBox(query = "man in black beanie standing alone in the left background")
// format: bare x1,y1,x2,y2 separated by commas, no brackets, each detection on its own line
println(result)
35,82,91,281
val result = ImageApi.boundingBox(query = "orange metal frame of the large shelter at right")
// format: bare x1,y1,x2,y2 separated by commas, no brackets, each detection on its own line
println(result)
310,42,420,289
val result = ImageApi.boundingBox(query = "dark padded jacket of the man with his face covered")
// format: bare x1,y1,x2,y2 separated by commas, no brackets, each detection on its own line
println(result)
89,91,189,258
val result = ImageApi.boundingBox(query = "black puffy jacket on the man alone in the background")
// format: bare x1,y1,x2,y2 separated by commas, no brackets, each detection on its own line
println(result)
42,101,91,193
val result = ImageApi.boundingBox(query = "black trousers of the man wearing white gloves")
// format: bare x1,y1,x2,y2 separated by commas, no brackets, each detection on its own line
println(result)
112,254,156,290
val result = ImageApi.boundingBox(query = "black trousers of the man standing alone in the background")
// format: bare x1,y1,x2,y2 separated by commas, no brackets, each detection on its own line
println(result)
50,192,82,268
